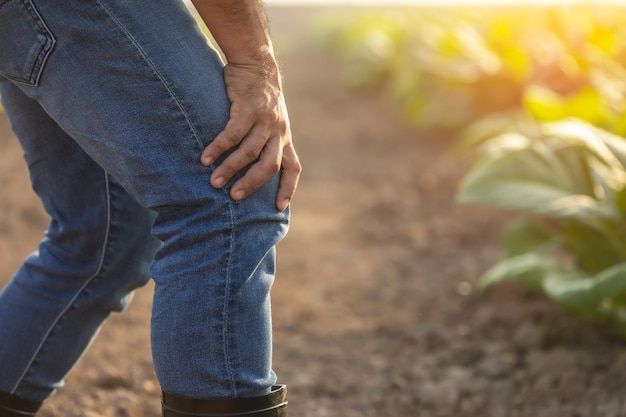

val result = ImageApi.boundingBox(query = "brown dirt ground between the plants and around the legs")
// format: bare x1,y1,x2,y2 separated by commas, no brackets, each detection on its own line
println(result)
0,8,626,417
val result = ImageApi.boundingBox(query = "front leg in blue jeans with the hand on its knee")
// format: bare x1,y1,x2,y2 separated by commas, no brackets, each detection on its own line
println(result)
0,0,288,399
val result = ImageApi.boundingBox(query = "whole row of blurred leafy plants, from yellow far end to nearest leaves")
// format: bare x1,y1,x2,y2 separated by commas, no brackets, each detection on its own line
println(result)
321,6,626,335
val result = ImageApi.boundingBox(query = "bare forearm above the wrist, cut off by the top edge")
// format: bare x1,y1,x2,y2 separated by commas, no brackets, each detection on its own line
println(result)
192,0,276,67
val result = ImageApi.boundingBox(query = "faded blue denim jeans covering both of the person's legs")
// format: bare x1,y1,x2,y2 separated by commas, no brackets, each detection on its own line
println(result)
0,0,288,401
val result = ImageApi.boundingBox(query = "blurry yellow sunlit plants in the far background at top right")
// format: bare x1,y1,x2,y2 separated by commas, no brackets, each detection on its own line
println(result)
321,6,626,133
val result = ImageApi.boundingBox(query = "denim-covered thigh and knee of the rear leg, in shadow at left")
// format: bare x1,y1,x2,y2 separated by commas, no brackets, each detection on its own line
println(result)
0,77,160,285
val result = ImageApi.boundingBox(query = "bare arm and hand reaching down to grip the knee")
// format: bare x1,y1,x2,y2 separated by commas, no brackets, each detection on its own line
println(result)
192,0,301,210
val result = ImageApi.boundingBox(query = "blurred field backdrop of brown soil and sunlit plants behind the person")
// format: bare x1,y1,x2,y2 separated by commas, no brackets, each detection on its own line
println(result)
0,0,626,417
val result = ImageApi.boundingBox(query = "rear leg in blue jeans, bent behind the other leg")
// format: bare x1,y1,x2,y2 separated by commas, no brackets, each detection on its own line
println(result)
0,80,160,401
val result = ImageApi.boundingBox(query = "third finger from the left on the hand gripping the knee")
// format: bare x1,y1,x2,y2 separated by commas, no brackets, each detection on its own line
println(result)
230,138,282,200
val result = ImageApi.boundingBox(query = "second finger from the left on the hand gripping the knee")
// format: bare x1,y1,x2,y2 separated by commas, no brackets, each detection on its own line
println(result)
211,122,267,188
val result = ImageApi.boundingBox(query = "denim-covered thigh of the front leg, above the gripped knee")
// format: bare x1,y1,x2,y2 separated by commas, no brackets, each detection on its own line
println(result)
0,0,230,207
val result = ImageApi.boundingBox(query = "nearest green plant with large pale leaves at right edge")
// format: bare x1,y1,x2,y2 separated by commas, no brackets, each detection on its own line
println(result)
458,118,626,333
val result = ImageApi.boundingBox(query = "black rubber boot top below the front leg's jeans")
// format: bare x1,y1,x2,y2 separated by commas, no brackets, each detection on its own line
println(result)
162,385,287,417
